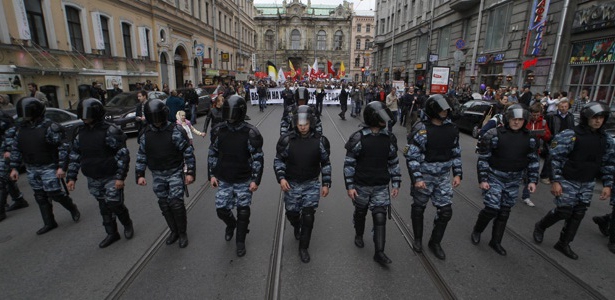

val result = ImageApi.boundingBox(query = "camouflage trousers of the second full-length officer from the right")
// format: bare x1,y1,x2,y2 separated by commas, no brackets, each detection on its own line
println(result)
483,168,525,210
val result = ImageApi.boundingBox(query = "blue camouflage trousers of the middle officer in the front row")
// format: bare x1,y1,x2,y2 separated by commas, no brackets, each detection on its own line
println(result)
284,179,320,212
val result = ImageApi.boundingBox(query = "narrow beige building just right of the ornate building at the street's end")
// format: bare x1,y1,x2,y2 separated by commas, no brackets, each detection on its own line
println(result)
349,11,375,82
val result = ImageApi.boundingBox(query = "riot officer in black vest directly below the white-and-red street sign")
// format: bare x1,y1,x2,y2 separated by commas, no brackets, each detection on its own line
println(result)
404,95,462,259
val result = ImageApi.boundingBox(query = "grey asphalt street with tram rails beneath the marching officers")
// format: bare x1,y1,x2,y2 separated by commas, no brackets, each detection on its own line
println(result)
0,106,615,299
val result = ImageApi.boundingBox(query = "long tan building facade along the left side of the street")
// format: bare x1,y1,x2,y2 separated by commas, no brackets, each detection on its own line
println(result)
0,0,255,108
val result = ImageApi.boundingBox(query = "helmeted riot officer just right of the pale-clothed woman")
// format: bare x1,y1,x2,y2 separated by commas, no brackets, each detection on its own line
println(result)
208,95,263,257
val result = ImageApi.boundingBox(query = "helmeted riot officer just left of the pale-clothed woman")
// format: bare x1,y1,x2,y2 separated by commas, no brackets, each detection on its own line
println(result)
135,99,196,248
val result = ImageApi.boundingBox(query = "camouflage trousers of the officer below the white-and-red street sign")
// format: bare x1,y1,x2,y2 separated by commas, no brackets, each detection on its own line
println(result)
411,172,453,207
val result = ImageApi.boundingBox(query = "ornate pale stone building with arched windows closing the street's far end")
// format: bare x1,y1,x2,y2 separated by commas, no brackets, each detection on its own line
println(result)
253,0,354,77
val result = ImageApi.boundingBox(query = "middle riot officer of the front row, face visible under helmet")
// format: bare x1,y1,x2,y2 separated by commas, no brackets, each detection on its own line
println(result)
273,105,331,263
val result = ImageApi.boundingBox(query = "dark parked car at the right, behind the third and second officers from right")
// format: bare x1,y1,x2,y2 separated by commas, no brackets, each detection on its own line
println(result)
452,100,493,138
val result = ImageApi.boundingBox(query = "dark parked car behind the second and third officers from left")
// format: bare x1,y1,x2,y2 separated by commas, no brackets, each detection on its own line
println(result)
105,91,167,133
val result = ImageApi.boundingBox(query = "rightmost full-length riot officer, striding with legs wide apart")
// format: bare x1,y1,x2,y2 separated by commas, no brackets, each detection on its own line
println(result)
533,102,615,259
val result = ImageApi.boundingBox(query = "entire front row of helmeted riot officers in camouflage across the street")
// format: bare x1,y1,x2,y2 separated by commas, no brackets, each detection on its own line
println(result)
0,95,615,265
